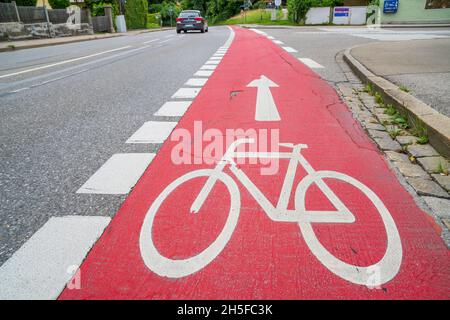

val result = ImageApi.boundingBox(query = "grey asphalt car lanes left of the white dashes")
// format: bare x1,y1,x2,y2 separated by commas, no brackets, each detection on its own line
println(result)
0,27,229,265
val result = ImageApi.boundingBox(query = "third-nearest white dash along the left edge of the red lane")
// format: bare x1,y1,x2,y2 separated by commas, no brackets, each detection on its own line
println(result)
126,121,177,143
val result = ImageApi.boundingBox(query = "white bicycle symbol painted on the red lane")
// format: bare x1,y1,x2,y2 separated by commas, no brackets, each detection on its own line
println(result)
139,139,402,286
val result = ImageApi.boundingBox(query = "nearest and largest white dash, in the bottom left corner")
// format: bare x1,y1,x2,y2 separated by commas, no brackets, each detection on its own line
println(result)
0,216,111,300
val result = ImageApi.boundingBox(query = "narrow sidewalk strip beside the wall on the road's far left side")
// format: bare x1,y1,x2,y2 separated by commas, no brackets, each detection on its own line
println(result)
0,28,172,52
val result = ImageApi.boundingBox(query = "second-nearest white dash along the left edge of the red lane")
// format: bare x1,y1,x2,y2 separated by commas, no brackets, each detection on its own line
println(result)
77,153,155,194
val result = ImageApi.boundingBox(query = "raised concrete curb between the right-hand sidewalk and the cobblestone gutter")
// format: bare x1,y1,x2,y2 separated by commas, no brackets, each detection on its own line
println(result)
344,47,450,158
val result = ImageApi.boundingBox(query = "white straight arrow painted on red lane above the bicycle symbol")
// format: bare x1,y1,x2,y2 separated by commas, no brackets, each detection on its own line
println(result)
247,75,281,121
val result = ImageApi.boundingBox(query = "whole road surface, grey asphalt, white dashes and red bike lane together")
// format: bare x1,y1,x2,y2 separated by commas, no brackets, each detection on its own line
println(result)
0,27,450,299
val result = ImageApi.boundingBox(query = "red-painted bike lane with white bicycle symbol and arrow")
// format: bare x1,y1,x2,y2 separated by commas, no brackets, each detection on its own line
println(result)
60,28,450,299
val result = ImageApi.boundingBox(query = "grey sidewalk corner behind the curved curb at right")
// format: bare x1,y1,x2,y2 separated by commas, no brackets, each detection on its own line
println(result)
351,39,450,117
